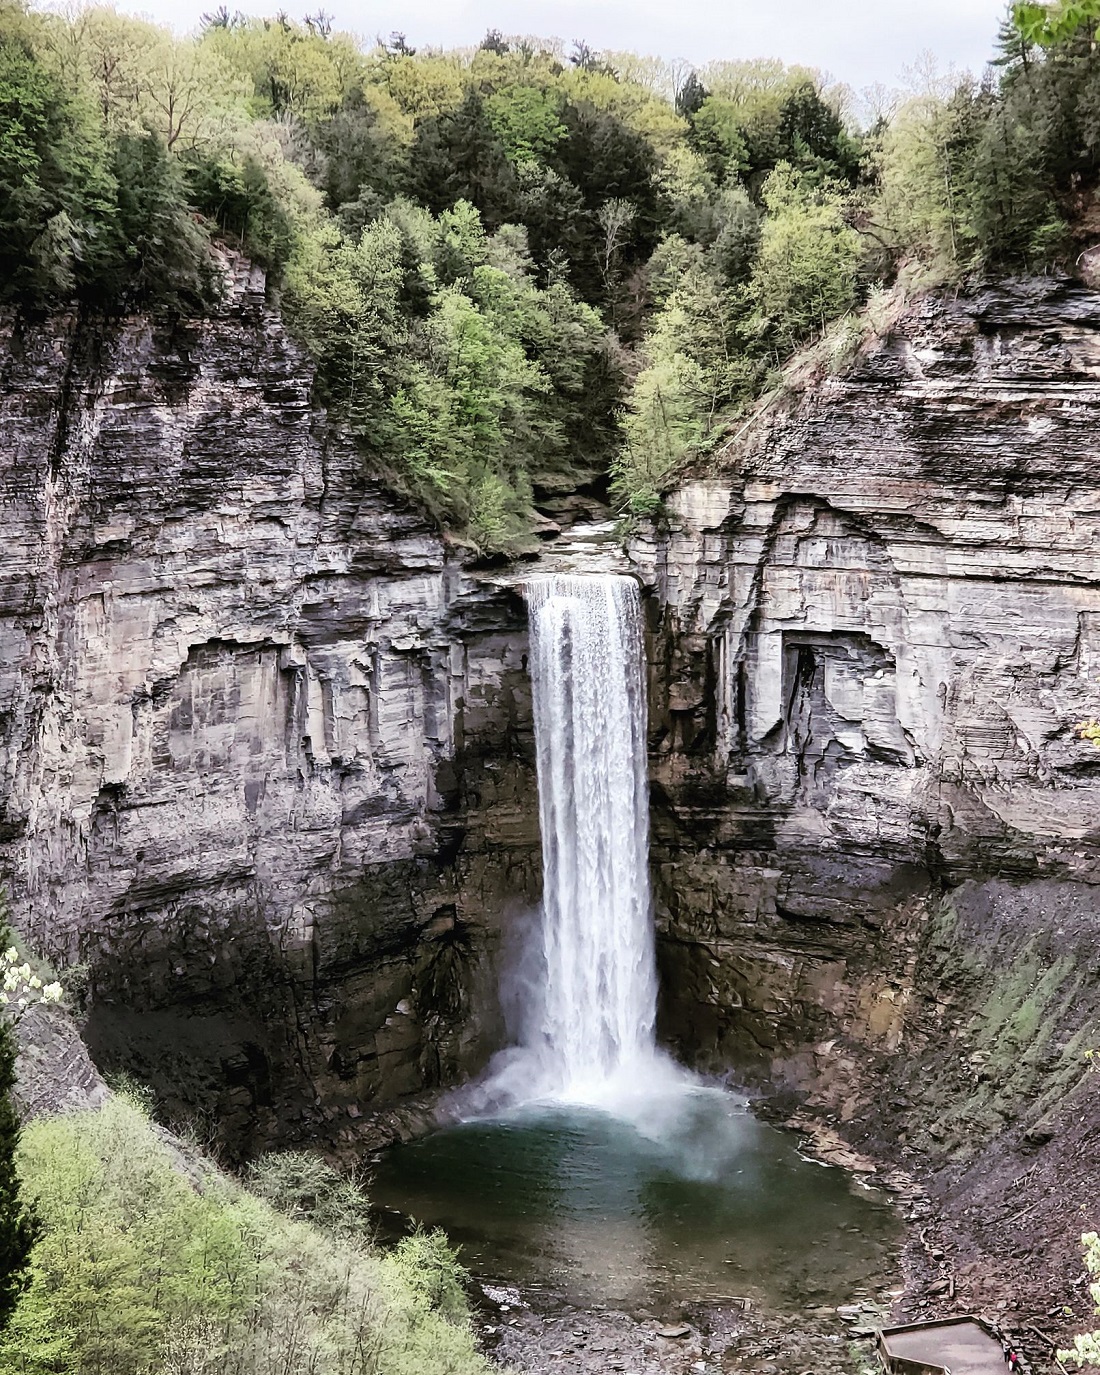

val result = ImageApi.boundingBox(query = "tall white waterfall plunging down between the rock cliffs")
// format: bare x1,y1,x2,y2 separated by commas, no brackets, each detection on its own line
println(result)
524,575,657,1099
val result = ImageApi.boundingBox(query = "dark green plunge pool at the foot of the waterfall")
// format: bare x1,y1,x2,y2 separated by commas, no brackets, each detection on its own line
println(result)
371,1089,901,1309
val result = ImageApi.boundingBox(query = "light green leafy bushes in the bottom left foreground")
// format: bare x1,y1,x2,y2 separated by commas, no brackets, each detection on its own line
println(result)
0,1097,488,1375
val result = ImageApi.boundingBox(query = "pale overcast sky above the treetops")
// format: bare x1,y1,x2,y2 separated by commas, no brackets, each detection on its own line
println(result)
120,0,1007,89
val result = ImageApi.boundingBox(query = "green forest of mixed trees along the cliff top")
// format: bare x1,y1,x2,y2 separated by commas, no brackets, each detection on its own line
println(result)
0,0,1100,551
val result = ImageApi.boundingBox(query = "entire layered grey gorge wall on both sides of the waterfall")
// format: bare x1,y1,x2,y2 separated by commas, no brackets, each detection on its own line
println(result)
0,264,1100,1301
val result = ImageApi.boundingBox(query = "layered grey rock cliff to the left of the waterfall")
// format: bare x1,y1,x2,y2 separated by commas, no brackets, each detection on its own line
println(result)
0,265,539,1152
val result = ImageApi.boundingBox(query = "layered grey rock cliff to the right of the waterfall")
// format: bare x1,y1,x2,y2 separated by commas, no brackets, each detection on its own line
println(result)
634,281,1100,1127
